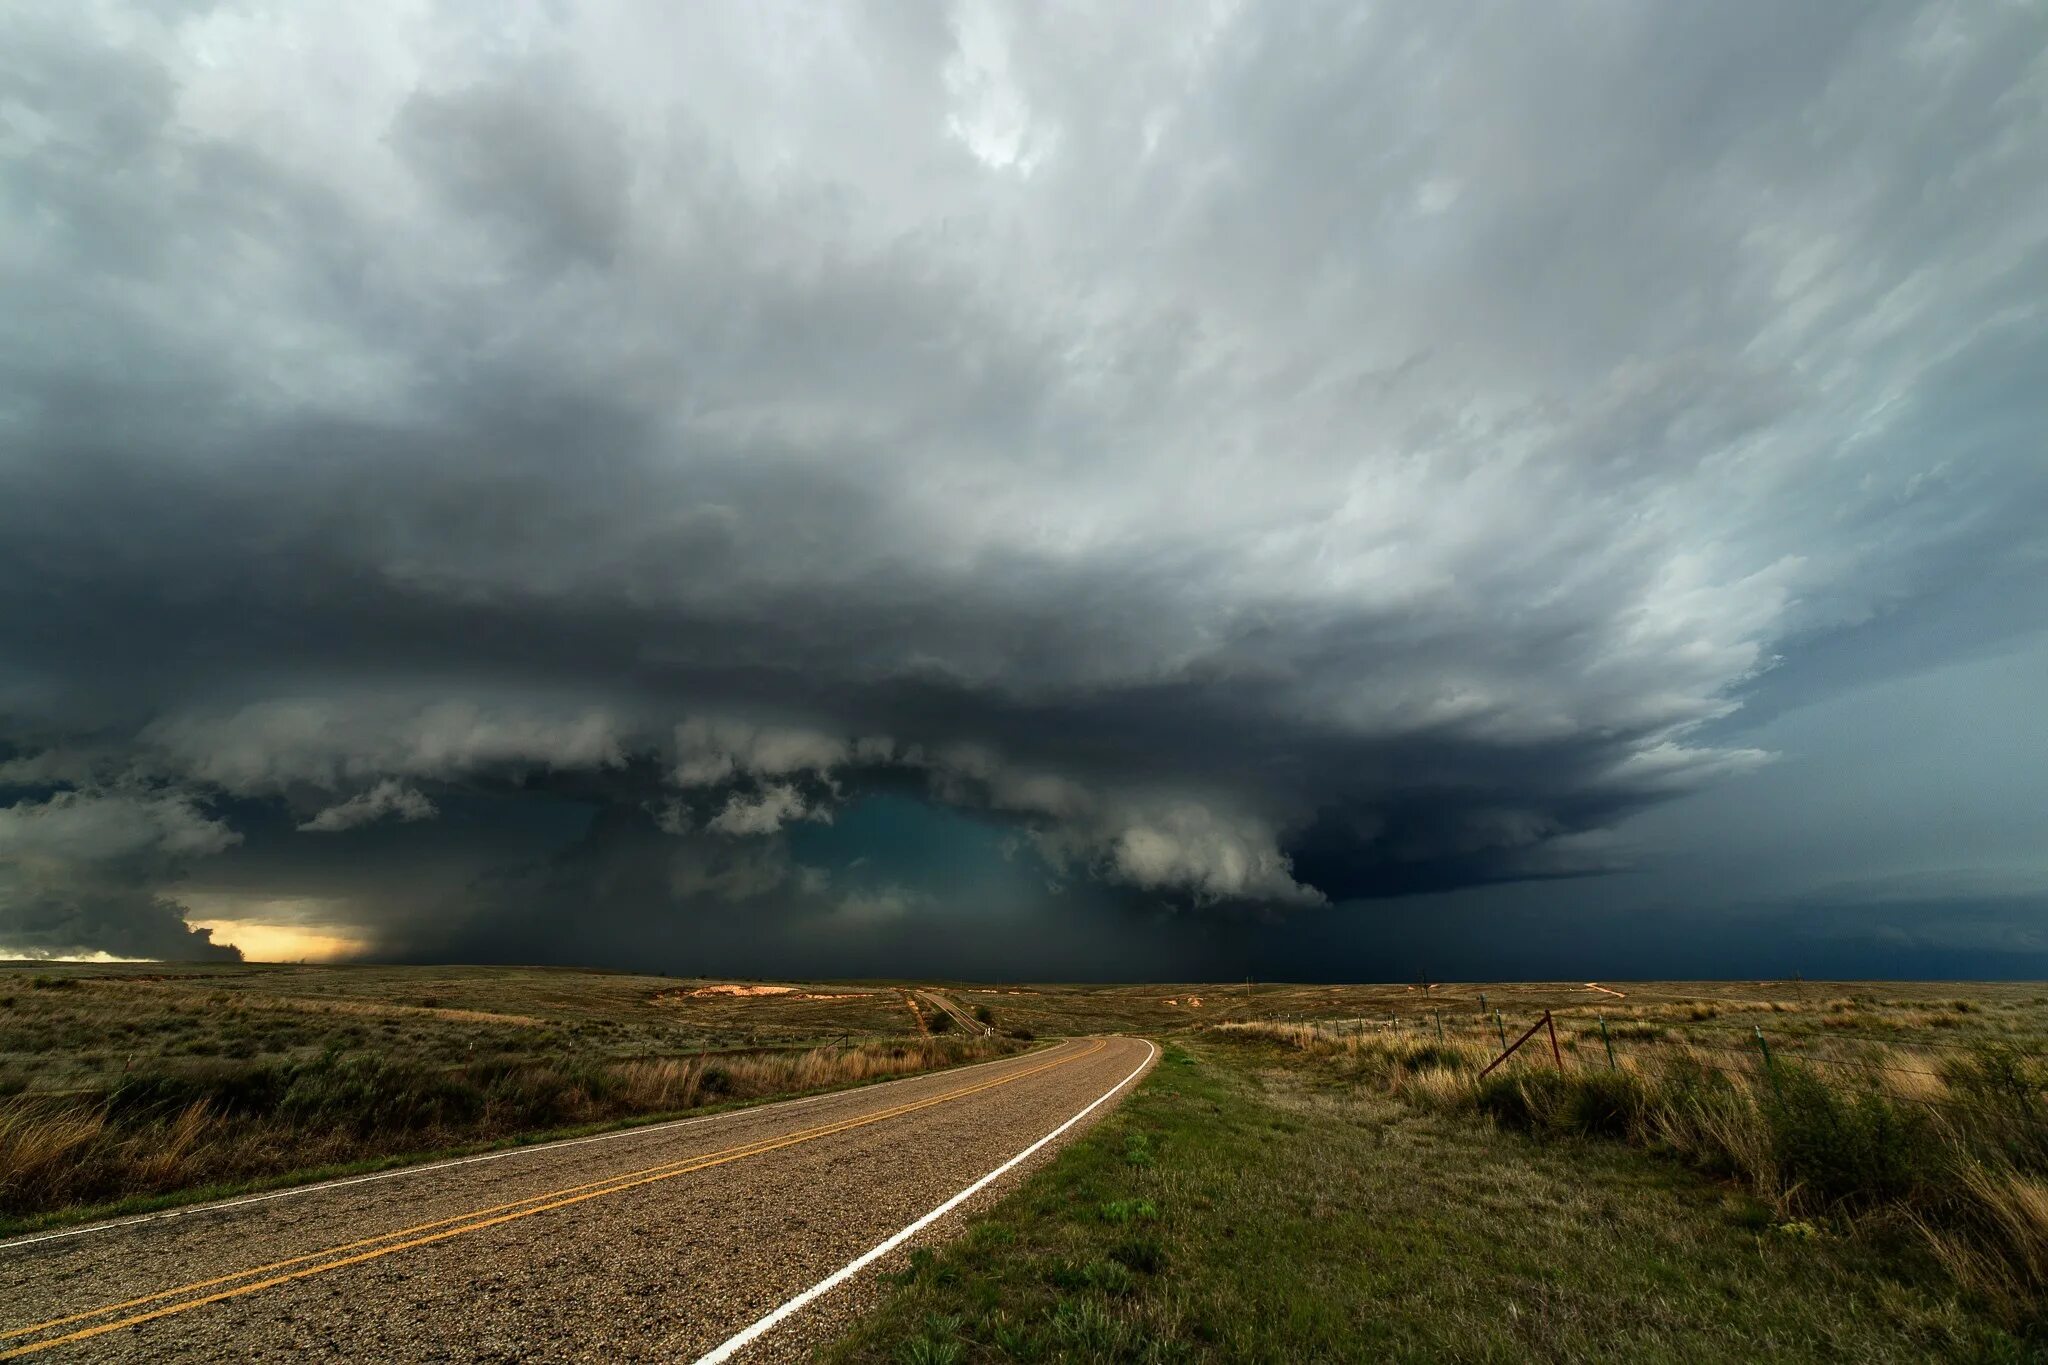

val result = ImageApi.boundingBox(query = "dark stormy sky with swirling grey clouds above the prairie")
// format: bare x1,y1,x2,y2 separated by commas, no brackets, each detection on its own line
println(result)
0,0,2048,978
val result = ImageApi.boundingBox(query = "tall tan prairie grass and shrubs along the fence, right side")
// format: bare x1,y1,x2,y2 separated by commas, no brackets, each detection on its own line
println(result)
1210,1007,2048,1328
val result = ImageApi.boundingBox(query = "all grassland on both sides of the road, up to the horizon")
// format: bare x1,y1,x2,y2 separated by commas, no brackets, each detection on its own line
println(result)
0,964,2048,1361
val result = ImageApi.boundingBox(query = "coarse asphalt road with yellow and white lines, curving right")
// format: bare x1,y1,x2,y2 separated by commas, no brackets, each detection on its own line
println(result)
0,1038,1155,1361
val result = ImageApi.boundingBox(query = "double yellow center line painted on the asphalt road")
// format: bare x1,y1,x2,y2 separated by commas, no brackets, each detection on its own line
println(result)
0,1040,1108,1361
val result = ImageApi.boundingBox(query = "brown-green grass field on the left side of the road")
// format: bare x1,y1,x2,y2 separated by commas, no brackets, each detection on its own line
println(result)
0,964,1026,1230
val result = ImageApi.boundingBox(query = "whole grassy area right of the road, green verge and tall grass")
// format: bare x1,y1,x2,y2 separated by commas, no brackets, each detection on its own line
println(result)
831,982,2048,1365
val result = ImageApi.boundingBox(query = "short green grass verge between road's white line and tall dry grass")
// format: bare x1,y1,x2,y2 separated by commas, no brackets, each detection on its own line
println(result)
821,1042,2034,1363
